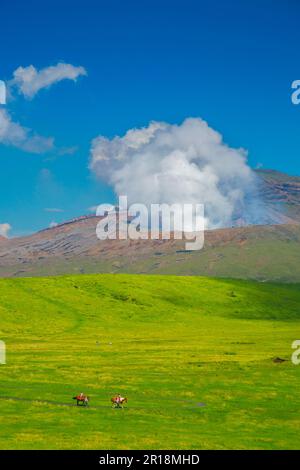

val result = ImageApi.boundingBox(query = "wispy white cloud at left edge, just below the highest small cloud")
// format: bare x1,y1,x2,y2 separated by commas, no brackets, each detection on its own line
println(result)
0,109,53,153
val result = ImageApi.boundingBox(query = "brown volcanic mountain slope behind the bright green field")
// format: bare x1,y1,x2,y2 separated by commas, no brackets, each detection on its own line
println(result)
0,170,300,282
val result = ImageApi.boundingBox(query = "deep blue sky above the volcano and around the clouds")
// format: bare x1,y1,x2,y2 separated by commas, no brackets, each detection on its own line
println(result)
0,0,300,235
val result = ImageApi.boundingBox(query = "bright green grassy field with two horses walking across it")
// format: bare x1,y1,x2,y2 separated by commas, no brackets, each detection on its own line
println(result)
0,275,300,449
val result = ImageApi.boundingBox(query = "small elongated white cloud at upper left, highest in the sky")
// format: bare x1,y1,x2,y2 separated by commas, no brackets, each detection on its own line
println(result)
10,63,87,98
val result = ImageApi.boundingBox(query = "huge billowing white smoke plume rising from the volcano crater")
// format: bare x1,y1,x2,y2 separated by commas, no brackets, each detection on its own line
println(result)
90,118,255,228
